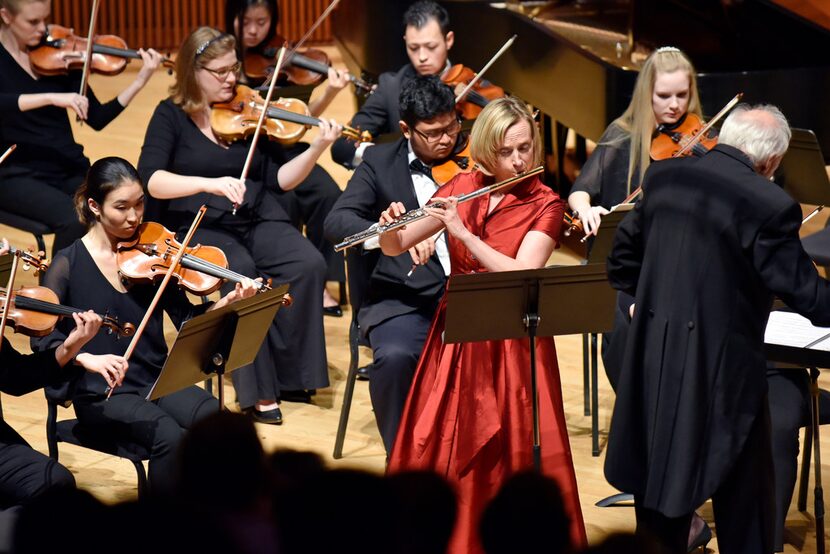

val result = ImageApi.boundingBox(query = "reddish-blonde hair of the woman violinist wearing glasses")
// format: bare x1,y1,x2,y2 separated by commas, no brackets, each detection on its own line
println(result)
170,27,236,114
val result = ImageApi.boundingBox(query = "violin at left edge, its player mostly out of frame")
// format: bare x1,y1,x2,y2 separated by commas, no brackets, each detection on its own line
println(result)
0,286,135,337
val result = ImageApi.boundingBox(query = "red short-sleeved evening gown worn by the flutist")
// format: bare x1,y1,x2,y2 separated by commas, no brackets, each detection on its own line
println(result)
388,172,586,554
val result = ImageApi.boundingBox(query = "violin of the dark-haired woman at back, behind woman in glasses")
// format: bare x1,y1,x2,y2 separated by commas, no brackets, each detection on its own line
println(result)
243,35,372,95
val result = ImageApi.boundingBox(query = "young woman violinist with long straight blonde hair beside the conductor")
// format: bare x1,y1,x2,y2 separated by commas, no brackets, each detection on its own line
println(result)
568,47,701,235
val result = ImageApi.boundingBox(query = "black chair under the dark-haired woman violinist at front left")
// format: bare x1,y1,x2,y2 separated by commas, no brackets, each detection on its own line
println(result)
46,388,150,499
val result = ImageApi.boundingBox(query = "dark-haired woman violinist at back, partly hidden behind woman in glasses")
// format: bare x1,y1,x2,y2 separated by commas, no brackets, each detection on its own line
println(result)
225,0,349,317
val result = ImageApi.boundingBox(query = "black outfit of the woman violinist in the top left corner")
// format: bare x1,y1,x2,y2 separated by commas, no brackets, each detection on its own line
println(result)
0,45,124,253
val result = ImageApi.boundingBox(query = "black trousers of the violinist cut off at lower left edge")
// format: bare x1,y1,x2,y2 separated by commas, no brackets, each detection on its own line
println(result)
0,427,75,508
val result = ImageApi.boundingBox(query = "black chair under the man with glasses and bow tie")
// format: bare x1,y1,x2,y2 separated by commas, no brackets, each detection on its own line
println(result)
332,248,380,460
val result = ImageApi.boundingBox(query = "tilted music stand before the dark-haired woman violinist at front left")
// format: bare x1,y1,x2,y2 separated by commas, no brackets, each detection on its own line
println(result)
147,285,288,410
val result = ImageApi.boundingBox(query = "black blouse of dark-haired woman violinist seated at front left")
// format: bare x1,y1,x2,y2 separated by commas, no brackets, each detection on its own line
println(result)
32,239,209,398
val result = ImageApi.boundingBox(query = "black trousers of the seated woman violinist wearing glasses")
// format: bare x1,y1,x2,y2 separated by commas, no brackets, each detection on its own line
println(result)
193,221,329,409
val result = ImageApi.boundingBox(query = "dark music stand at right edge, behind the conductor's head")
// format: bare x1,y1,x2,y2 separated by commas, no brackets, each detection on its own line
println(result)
775,129,830,206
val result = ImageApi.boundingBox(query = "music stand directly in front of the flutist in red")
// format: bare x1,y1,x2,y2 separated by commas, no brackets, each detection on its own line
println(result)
444,264,616,471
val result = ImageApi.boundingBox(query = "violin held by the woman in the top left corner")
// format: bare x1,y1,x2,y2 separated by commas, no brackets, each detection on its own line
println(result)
29,25,174,76
